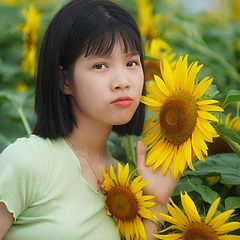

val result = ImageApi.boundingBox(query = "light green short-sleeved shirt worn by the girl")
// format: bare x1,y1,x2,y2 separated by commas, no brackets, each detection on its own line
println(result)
0,135,120,240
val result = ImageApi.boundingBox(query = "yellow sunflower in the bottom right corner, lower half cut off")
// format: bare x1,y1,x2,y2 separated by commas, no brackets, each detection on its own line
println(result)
155,193,240,240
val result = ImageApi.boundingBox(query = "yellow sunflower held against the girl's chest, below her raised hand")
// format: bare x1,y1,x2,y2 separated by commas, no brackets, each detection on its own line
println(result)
103,163,155,240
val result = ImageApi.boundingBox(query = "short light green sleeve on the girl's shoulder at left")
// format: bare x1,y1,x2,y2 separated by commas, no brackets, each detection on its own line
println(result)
0,138,40,220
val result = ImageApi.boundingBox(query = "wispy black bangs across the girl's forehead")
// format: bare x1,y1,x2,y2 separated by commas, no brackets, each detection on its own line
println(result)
83,28,141,57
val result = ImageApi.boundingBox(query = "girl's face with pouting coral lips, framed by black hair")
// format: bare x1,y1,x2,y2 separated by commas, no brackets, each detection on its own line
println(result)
64,41,144,126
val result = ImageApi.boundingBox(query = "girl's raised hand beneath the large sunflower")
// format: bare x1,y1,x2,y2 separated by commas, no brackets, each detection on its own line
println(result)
136,141,179,205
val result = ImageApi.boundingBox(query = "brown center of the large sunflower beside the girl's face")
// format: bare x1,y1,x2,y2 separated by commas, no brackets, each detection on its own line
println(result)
160,91,198,145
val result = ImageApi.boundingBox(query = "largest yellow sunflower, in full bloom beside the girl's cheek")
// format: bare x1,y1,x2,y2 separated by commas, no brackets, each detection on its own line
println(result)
141,56,223,178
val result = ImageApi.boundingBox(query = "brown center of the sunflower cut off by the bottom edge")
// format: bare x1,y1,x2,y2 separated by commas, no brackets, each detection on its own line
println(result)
183,223,218,240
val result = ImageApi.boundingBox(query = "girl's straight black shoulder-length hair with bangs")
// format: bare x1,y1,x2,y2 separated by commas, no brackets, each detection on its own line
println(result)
33,0,145,139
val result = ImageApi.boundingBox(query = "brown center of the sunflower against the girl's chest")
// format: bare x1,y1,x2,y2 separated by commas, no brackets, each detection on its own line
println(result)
106,186,138,221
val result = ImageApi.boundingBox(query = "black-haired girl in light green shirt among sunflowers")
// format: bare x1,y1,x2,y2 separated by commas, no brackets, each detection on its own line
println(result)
0,0,176,240
